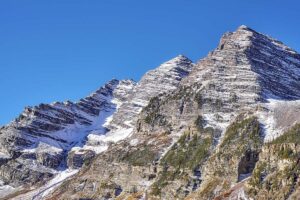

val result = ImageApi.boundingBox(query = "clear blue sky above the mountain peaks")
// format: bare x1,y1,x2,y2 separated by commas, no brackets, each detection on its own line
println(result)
0,0,300,125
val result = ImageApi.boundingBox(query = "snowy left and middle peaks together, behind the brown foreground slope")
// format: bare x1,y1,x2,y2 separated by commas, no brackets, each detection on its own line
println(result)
0,55,193,198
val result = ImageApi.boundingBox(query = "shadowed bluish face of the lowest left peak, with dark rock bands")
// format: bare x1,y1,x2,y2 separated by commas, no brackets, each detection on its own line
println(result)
1,80,134,153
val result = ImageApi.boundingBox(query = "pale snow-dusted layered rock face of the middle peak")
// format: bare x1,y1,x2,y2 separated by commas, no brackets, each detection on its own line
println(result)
106,55,194,130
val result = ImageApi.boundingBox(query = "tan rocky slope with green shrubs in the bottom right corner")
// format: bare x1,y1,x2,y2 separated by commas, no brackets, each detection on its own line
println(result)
245,124,300,199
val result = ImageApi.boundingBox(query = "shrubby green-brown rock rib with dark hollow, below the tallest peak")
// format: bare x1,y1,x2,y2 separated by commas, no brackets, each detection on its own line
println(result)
189,114,263,199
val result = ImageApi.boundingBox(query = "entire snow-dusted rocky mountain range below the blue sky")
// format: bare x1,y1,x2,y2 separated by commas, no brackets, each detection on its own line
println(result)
0,26,300,200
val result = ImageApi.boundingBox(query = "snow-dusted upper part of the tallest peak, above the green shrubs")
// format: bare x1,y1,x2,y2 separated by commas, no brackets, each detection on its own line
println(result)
183,25,300,138
